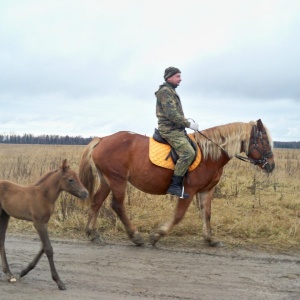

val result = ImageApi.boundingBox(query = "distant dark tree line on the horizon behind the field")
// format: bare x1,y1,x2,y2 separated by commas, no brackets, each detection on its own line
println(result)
0,134,300,149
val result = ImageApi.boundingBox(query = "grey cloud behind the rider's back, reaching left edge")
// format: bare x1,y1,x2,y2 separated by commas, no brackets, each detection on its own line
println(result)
0,53,120,97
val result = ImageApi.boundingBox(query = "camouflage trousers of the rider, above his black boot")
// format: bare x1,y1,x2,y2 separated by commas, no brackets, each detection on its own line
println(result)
159,130,196,176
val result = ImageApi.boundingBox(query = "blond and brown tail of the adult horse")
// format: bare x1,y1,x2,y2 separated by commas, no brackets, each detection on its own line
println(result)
79,138,101,202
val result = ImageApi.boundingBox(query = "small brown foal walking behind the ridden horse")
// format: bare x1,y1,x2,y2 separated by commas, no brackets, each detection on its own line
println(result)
0,159,88,290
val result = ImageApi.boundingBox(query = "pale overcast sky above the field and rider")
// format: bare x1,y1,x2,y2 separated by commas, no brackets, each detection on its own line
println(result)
0,0,300,141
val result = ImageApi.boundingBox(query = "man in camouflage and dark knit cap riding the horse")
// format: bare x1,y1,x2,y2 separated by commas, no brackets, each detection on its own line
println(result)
155,67,199,198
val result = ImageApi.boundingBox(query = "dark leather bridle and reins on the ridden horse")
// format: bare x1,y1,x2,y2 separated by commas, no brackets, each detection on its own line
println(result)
197,125,273,168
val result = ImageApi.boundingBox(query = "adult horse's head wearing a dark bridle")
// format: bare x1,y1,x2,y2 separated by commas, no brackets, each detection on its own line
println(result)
247,119,275,173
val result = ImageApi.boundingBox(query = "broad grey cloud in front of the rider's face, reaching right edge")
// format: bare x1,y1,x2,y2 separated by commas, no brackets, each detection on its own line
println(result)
185,39,300,101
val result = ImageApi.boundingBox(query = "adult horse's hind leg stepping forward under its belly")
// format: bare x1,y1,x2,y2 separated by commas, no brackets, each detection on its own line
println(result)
110,180,145,246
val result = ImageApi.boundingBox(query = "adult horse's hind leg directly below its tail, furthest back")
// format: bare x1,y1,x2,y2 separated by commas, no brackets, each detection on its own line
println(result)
85,178,111,244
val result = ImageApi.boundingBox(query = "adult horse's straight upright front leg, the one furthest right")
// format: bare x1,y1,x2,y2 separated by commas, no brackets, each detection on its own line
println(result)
197,188,223,247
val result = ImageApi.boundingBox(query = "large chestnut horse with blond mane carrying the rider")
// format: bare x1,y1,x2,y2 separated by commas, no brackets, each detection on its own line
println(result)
79,120,275,246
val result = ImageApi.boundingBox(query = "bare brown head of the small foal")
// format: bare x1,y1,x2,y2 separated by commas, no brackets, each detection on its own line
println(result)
60,159,89,200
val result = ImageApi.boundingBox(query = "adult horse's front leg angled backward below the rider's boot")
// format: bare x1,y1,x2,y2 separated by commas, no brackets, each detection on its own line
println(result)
149,195,193,246
